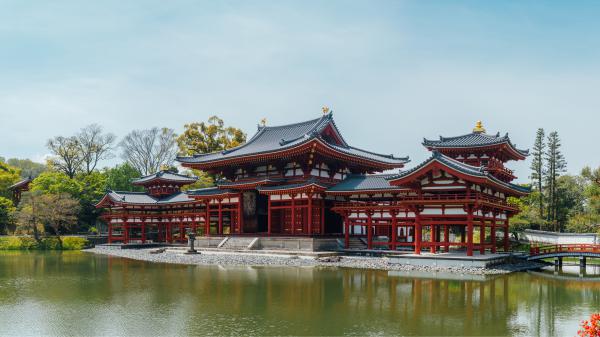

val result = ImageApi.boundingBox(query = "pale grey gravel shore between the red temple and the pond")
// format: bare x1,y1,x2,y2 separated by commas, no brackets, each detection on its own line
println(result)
85,246,543,275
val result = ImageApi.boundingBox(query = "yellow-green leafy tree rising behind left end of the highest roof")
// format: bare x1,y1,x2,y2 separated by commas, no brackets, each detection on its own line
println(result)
177,116,246,156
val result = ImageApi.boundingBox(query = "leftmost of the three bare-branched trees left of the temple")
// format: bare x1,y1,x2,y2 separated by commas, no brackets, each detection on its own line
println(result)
46,136,83,178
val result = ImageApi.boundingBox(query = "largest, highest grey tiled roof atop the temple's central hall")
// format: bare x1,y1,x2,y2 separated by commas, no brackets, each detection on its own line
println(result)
177,112,408,167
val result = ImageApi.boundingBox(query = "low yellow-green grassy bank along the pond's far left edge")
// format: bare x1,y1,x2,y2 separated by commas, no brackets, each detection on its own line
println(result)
0,236,90,250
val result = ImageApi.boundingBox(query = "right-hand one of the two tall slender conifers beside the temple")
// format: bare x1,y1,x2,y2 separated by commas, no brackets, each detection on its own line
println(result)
544,131,567,231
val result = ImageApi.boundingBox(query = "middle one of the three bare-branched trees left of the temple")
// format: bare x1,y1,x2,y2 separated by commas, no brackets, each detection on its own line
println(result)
77,124,115,174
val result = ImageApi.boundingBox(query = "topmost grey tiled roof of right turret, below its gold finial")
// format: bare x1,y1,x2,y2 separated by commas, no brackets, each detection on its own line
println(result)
423,132,529,156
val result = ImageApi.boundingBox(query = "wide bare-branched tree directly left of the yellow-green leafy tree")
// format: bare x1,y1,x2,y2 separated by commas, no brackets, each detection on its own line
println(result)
119,127,177,175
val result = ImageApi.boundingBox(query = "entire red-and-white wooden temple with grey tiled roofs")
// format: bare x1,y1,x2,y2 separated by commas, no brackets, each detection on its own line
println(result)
97,110,528,255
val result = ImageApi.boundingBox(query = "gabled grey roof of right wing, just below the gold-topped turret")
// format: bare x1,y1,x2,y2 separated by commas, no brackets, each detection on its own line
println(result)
386,150,531,194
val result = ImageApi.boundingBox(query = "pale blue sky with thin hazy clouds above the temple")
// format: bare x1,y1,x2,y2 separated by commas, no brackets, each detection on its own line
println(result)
0,0,600,182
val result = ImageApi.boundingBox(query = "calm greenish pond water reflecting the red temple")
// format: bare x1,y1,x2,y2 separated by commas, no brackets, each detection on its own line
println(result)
0,252,600,336
